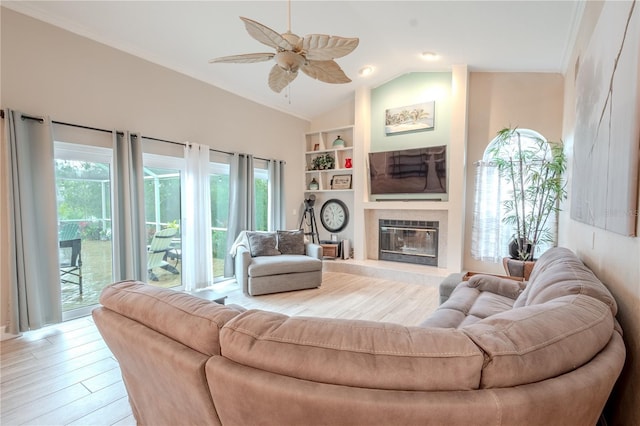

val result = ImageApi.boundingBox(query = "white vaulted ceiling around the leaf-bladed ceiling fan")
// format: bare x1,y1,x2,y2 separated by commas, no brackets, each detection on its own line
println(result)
2,0,582,119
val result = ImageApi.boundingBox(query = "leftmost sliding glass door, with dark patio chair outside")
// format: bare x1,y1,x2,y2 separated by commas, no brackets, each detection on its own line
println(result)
55,143,113,318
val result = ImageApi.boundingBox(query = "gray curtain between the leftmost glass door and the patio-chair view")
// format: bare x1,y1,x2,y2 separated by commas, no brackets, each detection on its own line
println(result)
112,131,147,281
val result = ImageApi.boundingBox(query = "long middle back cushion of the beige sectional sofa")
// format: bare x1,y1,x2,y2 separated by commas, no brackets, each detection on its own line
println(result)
220,310,484,391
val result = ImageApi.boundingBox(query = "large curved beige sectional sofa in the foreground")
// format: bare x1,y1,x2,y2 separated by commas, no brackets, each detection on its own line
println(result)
93,248,625,426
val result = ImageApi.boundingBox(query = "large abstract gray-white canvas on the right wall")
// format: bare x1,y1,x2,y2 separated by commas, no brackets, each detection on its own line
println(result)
571,2,640,236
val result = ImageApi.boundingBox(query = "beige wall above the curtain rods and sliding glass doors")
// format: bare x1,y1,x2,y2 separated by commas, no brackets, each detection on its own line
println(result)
0,8,309,332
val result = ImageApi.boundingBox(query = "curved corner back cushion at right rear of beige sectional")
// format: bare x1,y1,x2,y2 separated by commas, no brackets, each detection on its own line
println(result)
462,295,614,388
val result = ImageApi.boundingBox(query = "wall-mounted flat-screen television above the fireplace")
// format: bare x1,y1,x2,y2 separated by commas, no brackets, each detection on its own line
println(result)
369,145,447,195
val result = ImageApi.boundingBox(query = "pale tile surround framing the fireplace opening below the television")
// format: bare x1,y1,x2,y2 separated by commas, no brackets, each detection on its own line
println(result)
364,209,448,268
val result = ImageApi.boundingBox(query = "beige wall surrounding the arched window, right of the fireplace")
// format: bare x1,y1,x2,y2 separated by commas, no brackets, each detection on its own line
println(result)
464,72,564,274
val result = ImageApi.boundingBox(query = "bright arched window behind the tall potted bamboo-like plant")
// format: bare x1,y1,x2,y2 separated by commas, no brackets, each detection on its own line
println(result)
471,129,556,263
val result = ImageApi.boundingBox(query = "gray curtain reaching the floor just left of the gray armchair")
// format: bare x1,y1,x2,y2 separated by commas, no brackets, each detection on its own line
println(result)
224,153,255,277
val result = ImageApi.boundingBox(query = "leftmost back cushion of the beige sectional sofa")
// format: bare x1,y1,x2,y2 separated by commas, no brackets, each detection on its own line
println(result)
100,281,244,355
